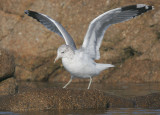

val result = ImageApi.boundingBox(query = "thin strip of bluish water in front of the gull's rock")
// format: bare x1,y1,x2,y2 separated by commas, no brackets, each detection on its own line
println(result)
0,108,160,115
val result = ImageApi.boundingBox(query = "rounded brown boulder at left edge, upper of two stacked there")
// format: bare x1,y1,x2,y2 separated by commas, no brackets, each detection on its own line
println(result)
0,48,15,81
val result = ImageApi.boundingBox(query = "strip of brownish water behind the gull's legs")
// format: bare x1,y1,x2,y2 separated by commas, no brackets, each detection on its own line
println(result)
19,82,160,98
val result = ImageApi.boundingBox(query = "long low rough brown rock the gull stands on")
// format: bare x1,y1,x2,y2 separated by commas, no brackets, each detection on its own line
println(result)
0,84,160,112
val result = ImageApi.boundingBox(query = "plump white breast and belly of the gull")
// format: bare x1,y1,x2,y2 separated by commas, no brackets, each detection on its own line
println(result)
62,52,97,78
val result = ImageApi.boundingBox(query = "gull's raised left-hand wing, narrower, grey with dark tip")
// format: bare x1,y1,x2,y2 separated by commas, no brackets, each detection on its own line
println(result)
25,10,76,50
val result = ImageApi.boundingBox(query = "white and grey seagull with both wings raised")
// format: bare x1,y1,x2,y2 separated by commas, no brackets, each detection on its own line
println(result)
25,4,154,89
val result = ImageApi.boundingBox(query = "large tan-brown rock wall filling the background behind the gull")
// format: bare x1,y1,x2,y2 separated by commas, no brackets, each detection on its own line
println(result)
0,0,160,82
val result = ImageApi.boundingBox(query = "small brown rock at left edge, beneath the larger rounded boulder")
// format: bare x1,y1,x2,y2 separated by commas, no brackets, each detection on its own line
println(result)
0,77,18,96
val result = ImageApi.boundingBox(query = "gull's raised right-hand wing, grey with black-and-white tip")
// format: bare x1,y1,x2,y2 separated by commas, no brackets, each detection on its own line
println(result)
82,4,153,59
